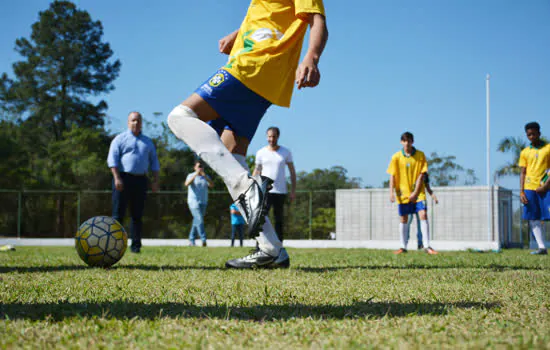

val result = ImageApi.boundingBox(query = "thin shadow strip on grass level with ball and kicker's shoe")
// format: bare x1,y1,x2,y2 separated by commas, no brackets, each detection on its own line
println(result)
0,264,547,273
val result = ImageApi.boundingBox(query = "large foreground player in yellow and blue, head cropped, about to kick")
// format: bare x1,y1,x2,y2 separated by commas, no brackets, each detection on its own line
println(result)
168,0,328,268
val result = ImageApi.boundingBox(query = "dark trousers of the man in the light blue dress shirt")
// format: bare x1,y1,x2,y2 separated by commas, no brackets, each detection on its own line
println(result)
113,173,147,249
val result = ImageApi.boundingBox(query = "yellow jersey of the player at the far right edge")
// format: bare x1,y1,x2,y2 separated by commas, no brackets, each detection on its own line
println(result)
518,143,550,190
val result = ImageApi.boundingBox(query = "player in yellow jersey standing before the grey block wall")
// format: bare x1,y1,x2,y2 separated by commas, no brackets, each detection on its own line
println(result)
387,132,437,254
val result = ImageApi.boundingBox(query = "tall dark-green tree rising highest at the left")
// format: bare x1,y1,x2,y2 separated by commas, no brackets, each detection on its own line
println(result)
0,1,121,232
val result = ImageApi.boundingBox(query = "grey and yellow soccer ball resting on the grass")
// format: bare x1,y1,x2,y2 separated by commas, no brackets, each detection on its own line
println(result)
75,216,128,267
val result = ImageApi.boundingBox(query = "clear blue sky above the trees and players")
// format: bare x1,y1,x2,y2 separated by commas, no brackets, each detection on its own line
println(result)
0,0,550,188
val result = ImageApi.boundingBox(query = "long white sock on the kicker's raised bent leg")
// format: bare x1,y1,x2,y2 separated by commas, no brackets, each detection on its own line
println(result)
168,105,252,200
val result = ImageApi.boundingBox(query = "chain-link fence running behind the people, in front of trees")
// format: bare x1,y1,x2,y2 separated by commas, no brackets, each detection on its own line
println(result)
0,190,550,247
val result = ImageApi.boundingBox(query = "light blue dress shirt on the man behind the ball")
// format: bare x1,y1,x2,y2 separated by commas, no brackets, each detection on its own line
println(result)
107,129,160,175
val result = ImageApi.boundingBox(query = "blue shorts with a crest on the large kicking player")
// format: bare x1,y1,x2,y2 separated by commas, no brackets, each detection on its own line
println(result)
195,69,271,141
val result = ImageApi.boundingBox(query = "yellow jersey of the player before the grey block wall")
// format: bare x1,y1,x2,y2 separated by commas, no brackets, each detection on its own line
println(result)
387,148,428,204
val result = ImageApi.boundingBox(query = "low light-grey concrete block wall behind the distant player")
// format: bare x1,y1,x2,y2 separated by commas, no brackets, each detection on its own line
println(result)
336,186,512,241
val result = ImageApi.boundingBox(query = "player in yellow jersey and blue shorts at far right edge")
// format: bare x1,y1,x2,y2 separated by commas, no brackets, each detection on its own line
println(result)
518,122,550,255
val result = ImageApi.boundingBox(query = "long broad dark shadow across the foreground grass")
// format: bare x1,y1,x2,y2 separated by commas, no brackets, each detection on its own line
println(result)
0,301,500,321
